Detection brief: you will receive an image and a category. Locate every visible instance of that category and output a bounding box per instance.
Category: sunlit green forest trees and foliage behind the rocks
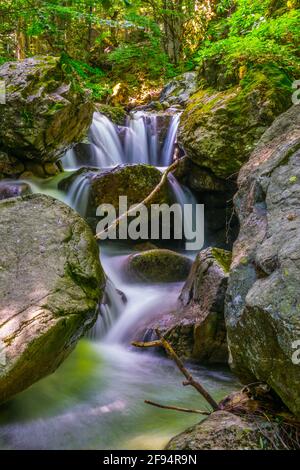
[0,0,300,100]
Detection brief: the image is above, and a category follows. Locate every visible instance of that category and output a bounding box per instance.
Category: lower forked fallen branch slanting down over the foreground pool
[131,329,220,411]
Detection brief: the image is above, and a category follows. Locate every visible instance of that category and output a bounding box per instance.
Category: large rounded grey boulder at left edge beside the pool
[0,195,104,402]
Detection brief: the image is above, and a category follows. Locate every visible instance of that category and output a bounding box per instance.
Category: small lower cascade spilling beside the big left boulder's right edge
[87,278,126,340]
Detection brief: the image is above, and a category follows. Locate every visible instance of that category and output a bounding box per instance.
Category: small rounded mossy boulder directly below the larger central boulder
[127,249,192,283]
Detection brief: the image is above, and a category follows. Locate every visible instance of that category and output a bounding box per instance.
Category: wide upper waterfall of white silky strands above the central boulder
[62,111,180,170]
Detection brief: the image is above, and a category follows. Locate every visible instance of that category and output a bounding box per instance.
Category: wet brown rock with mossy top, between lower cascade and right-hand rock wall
[139,248,231,363]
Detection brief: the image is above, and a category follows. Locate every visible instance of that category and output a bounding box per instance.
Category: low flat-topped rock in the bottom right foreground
[166,411,277,450]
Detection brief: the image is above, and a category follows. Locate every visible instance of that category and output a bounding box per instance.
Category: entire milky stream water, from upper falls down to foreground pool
[0,112,238,450]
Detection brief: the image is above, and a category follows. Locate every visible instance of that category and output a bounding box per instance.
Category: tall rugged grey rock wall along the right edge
[226,105,300,417]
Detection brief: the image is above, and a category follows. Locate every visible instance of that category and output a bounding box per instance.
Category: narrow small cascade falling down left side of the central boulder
[66,174,90,217]
